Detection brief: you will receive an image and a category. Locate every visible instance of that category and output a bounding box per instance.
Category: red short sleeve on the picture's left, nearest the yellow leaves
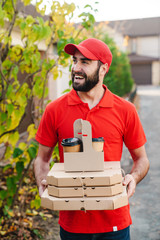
[36,107,58,147]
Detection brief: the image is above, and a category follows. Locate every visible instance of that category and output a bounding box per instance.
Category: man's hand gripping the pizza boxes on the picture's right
[122,174,136,198]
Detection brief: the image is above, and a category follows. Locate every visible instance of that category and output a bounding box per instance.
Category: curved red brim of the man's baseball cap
[64,43,98,60]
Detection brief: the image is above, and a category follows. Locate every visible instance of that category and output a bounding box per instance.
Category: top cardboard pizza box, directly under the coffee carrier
[47,168,122,187]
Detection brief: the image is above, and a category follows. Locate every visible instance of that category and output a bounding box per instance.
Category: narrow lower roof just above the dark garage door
[128,54,158,64]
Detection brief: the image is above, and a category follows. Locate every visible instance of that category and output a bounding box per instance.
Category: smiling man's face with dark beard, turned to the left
[71,51,100,92]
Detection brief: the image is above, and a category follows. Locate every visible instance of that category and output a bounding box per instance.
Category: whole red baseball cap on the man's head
[64,38,112,67]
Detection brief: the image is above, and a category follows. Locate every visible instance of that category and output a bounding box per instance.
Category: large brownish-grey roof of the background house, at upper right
[108,17,160,37]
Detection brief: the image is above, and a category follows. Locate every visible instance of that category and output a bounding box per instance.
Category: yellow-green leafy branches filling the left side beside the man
[0,0,94,233]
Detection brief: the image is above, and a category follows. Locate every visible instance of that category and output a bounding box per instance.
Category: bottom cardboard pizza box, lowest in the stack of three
[41,187,128,211]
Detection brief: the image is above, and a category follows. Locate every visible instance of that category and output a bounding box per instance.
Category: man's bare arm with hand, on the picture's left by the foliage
[34,144,53,196]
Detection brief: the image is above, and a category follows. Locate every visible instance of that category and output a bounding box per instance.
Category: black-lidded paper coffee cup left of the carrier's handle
[61,138,82,152]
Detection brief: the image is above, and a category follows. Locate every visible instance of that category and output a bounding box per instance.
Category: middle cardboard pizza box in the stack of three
[48,183,123,198]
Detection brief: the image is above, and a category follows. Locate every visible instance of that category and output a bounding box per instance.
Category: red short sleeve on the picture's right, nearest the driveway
[124,107,147,149]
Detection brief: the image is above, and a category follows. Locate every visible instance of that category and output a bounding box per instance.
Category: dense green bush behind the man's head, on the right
[103,35,133,96]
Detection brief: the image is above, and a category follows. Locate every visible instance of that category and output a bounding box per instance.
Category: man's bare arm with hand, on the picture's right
[123,146,149,197]
